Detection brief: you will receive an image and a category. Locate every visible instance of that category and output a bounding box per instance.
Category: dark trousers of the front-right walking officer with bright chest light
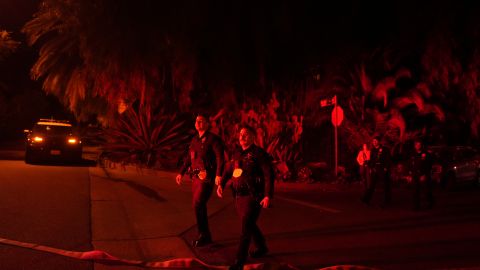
[235,195,266,264]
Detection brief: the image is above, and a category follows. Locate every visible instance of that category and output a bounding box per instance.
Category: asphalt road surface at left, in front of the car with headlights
[0,160,93,270]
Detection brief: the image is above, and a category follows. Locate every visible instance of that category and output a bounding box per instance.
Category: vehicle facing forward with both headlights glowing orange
[24,119,82,163]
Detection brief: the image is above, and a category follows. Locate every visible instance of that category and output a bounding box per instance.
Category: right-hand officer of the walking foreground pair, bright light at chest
[217,126,274,269]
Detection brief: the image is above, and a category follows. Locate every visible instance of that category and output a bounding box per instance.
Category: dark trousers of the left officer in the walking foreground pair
[192,177,213,237]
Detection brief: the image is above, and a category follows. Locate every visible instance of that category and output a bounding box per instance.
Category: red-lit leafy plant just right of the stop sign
[338,44,445,155]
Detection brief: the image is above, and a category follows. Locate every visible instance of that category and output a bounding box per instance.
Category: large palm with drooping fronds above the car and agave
[23,0,199,122]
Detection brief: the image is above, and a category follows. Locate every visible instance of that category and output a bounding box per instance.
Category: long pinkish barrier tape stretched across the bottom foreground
[0,238,300,270]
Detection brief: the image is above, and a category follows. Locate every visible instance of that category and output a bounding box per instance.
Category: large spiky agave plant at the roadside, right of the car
[103,107,190,167]
